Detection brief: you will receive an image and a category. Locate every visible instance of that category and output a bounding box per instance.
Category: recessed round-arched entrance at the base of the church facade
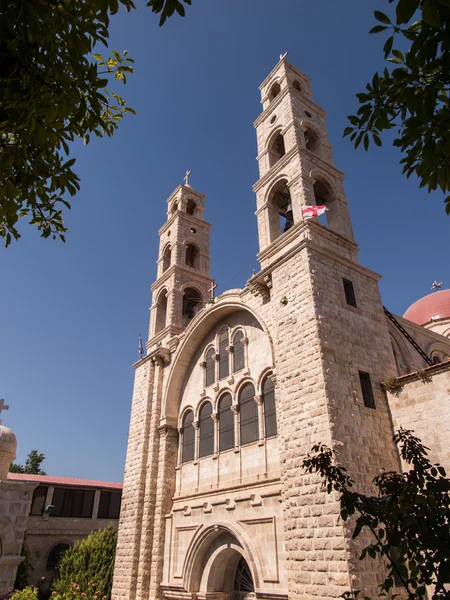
[188,526,258,600]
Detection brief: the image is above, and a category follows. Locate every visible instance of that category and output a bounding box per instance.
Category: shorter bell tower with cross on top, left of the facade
[147,175,214,349]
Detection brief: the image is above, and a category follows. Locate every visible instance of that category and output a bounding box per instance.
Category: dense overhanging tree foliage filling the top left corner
[0,0,191,246]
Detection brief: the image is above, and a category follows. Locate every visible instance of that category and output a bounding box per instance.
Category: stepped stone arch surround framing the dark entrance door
[183,523,262,598]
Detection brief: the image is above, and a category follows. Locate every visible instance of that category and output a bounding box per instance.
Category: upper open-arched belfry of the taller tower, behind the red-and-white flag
[253,56,353,267]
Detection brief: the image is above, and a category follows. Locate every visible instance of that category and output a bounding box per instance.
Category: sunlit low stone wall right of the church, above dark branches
[387,361,450,476]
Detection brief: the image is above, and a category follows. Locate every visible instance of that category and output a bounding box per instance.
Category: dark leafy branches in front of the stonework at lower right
[303,429,450,600]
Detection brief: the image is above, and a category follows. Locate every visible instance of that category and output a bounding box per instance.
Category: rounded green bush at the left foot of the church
[53,525,117,600]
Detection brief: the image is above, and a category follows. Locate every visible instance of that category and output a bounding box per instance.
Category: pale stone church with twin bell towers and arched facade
[113,57,450,600]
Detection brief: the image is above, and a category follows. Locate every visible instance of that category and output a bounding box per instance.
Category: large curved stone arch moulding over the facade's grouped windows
[161,296,275,427]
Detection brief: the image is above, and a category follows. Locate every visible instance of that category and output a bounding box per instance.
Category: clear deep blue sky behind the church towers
[0,0,450,481]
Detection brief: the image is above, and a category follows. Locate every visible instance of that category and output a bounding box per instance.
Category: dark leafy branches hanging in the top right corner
[344,0,450,214]
